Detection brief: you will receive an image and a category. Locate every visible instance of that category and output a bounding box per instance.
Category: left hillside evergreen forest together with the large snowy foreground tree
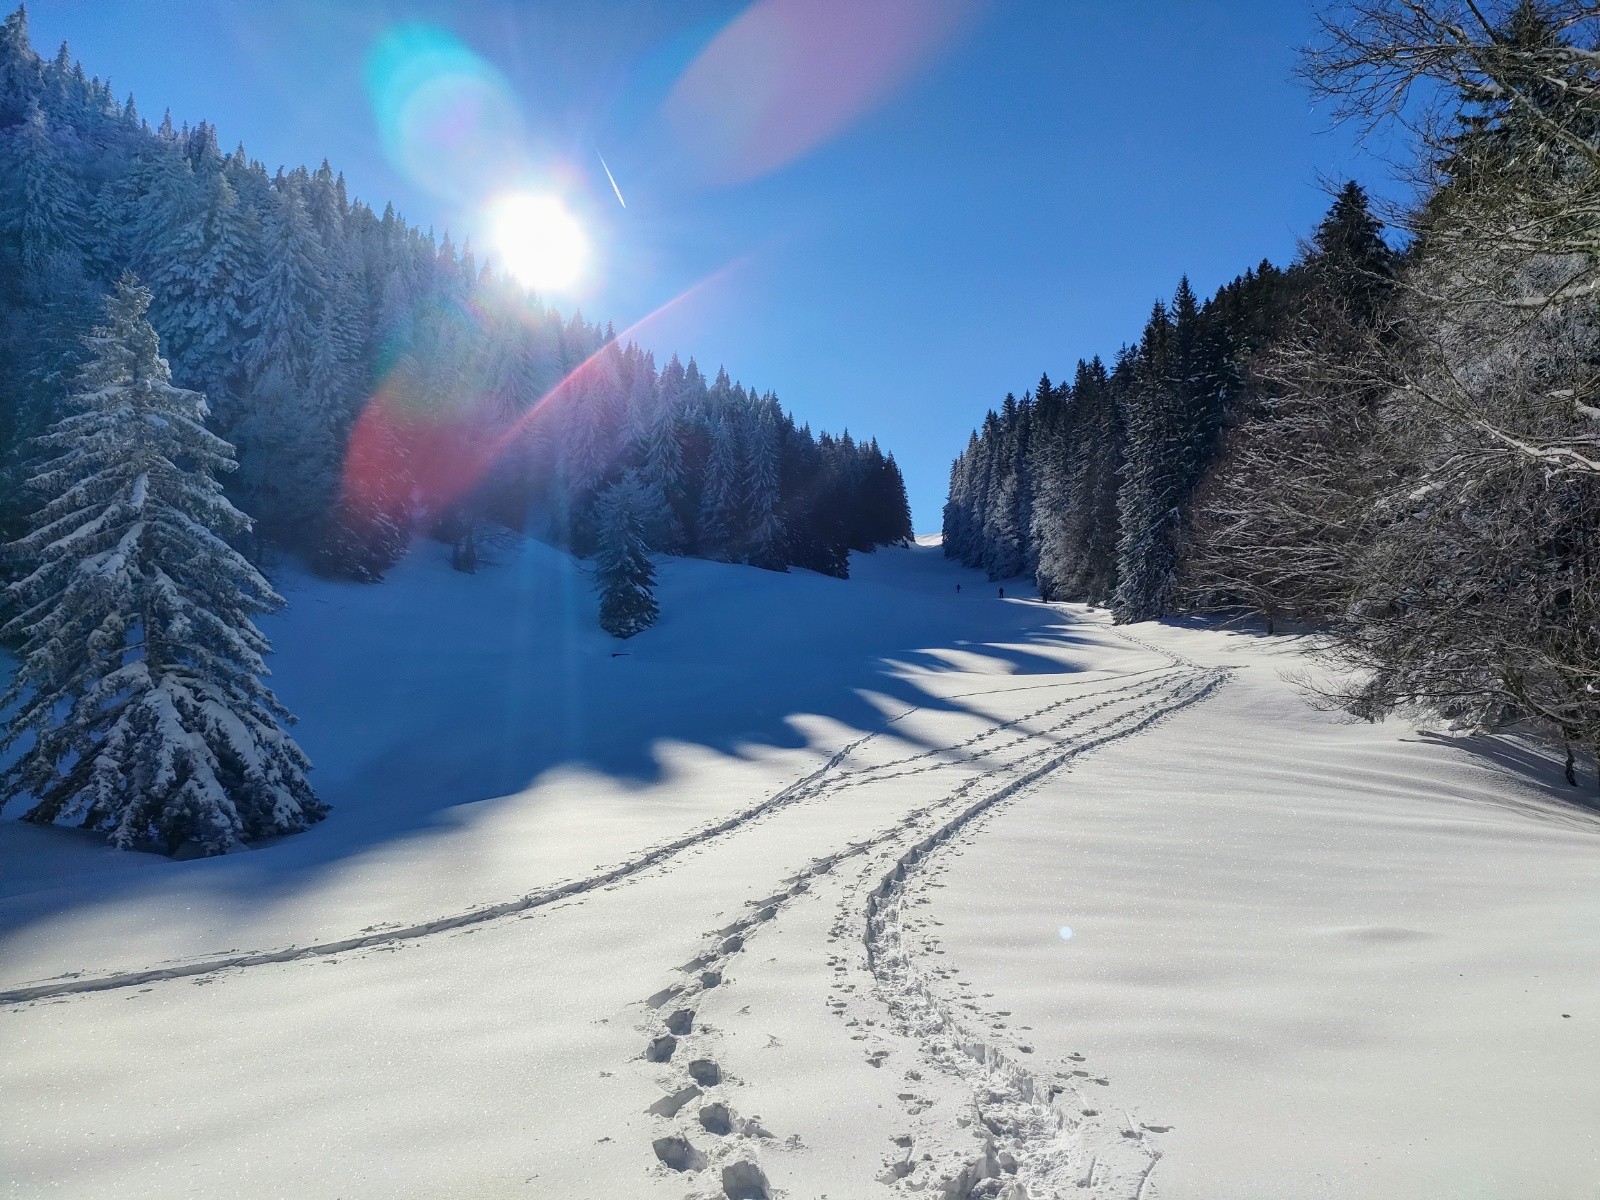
[0,10,910,854]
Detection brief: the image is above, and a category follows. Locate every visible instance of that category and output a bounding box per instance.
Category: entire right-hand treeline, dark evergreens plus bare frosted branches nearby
[946,0,1600,776]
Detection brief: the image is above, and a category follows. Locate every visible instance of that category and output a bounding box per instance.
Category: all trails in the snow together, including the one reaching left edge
[0,630,1230,1200]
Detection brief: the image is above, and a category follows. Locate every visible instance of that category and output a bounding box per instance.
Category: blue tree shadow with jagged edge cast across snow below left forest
[0,542,1126,966]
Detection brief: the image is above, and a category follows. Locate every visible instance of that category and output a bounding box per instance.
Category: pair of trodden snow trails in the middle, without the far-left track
[640,624,1230,1200]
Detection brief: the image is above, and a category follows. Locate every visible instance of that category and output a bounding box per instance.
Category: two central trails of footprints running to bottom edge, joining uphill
[640,630,1232,1200]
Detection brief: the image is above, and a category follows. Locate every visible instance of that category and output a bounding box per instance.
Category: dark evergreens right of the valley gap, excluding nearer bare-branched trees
[944,241,1324,621]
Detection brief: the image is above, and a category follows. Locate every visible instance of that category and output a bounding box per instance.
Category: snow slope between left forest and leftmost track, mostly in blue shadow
[0,542,1082,989]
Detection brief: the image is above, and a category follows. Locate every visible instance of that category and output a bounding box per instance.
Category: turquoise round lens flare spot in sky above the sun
[366,24,528,200]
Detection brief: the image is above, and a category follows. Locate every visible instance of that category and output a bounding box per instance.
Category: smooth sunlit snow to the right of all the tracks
[914,626,1600,1200]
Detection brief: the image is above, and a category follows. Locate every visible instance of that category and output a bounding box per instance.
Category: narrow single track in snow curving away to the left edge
[0,669,1177,1008]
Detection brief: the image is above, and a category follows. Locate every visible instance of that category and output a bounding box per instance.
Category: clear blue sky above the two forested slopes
[29,0,1394,531]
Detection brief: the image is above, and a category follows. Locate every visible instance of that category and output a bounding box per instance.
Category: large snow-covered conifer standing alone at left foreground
[0,275,326,854]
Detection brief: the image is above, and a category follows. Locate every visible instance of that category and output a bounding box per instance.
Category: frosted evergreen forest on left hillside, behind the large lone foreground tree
[0,10,910,595]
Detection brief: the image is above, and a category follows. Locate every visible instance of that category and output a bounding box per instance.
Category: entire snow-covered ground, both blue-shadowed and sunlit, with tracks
[0,547,1600,1200]
